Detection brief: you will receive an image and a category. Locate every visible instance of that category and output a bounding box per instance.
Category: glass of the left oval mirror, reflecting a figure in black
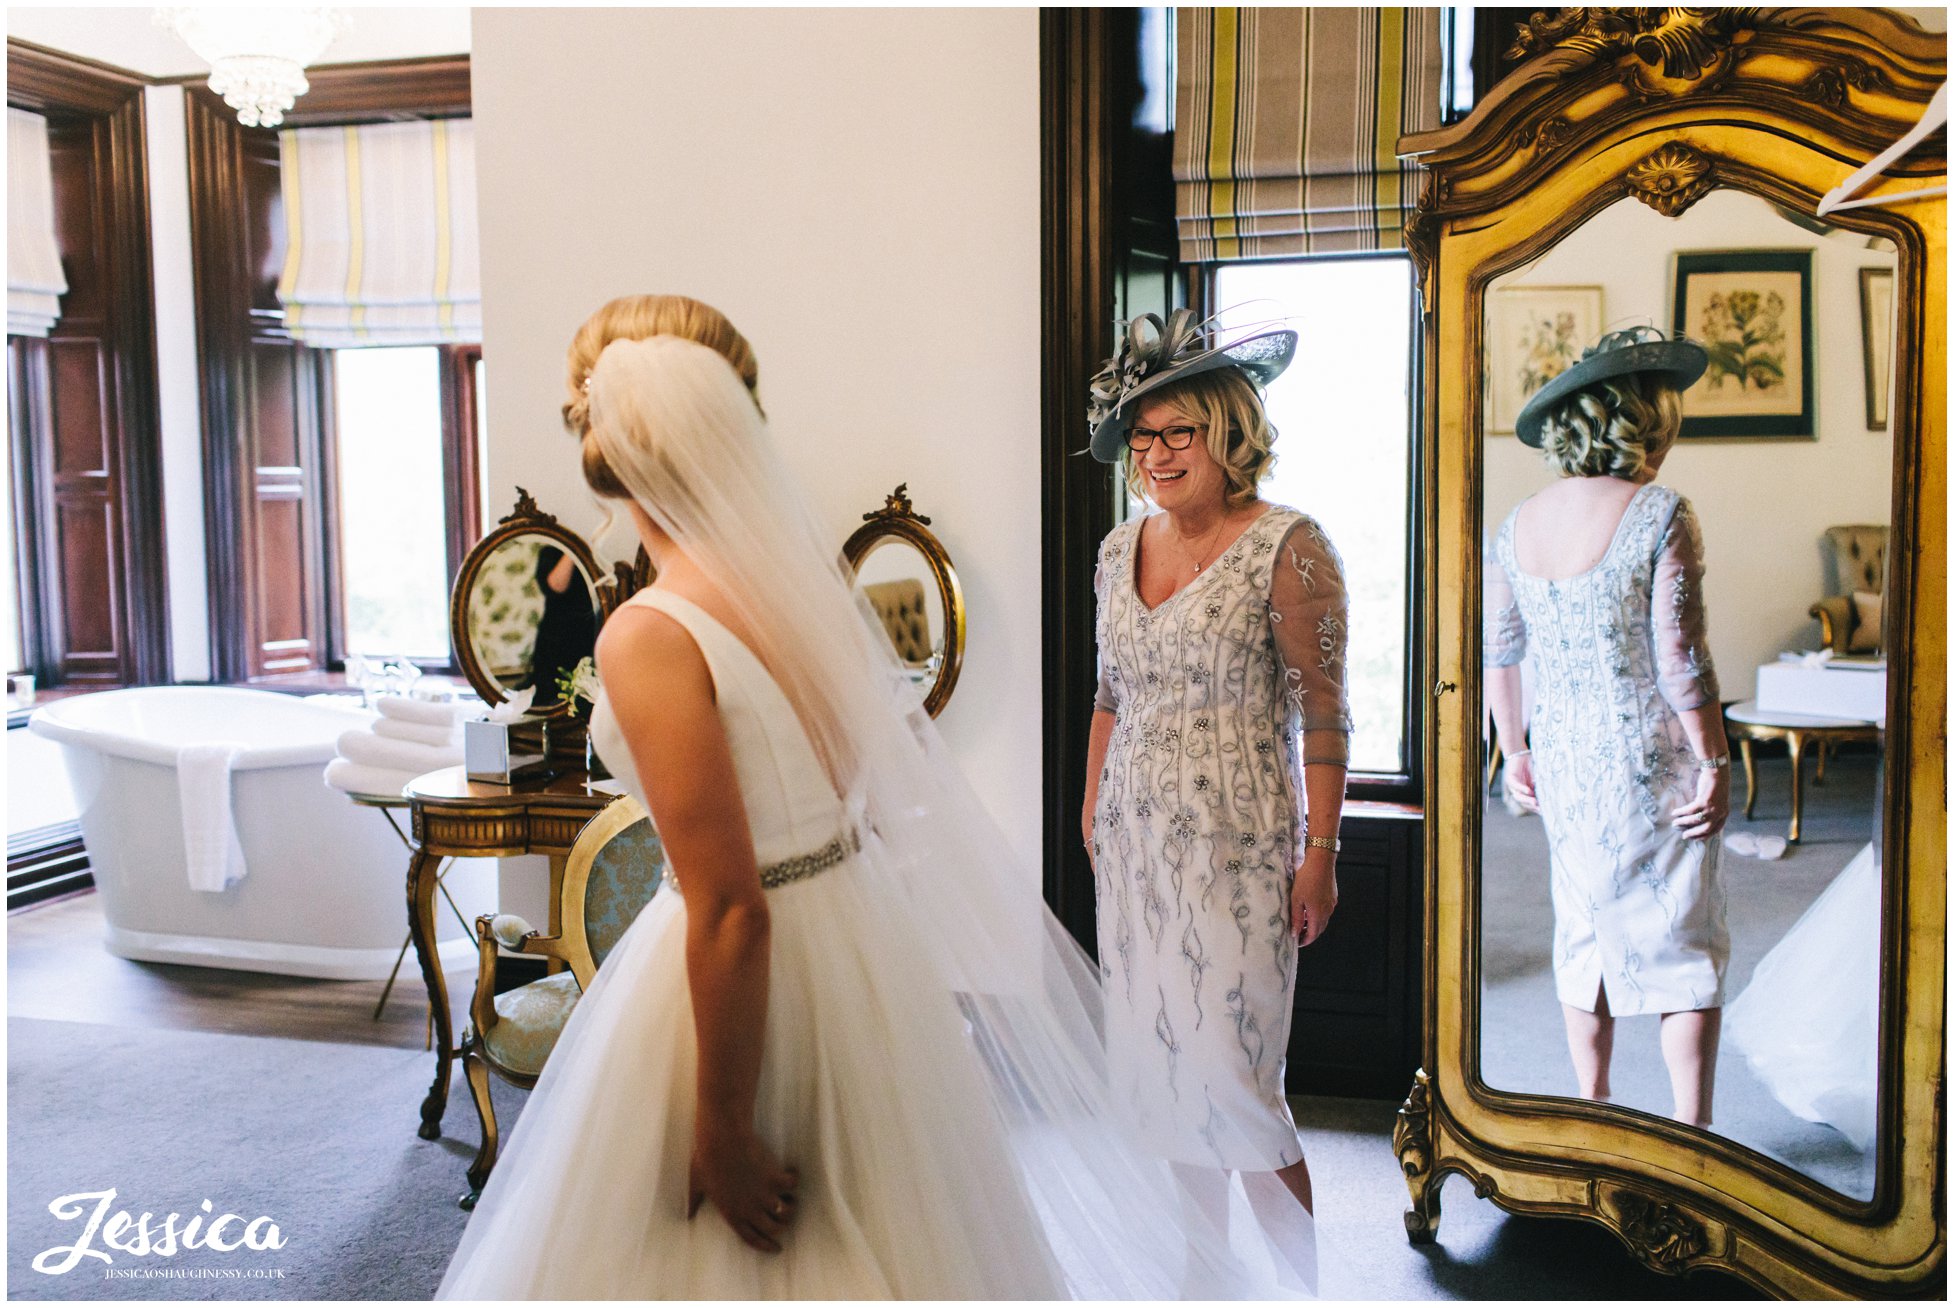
[467,532,598,708]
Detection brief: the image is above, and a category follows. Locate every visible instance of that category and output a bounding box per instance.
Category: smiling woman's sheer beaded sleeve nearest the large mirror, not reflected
[1268,518,1350,764]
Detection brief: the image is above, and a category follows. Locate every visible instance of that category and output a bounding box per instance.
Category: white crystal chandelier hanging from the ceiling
[156,4,346,127]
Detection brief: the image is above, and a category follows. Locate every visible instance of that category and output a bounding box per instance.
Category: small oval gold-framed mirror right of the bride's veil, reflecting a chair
[842,481,965,718]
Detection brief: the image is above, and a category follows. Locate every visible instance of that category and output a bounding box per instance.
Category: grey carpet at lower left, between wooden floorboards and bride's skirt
[8,1019,522,1300]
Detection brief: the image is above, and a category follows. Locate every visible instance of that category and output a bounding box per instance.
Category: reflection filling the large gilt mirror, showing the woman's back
[1479,192,1895,1199]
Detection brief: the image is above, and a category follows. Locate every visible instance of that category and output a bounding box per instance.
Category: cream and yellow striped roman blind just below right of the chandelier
[277,117,483,348]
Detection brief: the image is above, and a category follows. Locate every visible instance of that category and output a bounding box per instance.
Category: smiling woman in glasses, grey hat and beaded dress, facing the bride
[1083,313,1350,1222]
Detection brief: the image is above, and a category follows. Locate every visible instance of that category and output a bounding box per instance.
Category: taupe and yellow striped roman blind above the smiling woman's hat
[1174,6,1442,262]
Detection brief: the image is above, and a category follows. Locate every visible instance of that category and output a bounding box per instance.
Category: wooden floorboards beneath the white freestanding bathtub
[6,892,457,1050]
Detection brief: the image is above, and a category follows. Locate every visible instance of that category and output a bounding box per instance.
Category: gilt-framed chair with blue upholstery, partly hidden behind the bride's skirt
[461,796,664,1208]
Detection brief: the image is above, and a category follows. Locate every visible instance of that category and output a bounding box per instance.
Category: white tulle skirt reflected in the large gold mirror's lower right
[1723,845,1880,1150]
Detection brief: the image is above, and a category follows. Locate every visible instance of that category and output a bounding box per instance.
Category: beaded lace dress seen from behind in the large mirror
[1485,483,1729,1017]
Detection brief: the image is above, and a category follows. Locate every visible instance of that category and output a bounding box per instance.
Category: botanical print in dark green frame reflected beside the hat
[1675,250,1817,438]
